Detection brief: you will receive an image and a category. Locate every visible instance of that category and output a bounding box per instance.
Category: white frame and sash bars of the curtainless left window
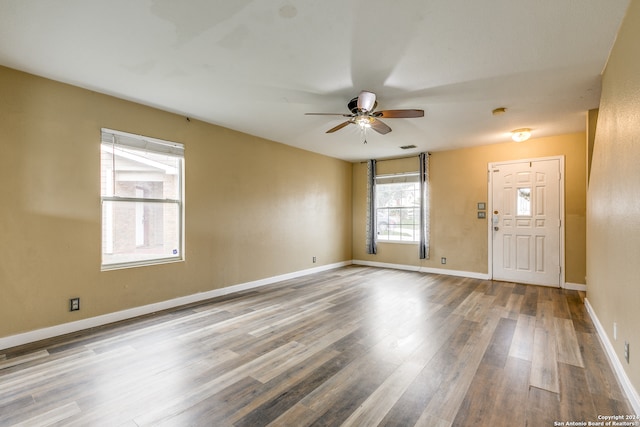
[100,128,185,271]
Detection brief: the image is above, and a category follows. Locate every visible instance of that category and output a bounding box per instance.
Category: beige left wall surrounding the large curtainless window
[0,68,352,337]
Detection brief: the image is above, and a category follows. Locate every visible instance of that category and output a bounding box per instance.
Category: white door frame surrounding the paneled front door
[487,155,566,288]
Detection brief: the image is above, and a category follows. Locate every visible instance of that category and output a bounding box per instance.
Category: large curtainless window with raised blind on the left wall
[100,129,184,270]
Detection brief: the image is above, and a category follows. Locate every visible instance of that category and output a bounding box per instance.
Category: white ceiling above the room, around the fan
[0,0,629,161]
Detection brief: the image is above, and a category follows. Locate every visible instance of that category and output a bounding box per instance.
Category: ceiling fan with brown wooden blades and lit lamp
[305,91,424,136]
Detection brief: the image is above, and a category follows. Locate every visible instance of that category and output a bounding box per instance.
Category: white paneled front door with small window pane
[488,158,562,287]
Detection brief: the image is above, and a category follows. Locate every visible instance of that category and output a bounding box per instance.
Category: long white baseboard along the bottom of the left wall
[0,261,351,350]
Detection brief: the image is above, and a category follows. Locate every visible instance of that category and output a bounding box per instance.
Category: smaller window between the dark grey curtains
[376,173,420,242]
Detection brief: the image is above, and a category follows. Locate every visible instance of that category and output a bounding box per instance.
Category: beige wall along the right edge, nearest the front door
[587,0,640,390]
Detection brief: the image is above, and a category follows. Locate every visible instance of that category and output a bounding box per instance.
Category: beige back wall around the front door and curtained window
[353,133,586,284]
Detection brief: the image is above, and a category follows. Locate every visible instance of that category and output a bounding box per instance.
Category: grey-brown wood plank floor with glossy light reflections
[0,266,632,427]
